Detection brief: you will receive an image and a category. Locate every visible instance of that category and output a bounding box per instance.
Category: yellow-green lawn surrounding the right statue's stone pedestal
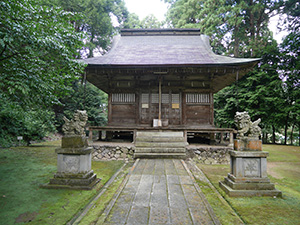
[197,145,300,225]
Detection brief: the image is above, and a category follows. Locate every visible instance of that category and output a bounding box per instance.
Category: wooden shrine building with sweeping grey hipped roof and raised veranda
[84,29,259,154]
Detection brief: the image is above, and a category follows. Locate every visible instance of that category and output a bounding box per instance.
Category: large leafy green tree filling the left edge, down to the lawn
[0,0,84,146]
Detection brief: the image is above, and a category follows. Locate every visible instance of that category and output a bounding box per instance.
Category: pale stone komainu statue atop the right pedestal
[234,112,261,139]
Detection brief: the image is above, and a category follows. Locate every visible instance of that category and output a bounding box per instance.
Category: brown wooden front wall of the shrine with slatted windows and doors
[108,90,213,127]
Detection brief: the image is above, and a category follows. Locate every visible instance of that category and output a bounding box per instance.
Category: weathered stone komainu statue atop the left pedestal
[62,110,88,136]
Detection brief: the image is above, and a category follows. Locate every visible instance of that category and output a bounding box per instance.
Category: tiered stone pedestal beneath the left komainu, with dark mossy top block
[44,135,100,190]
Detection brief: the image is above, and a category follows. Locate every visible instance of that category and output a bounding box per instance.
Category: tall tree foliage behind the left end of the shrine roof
[42,0,128,58]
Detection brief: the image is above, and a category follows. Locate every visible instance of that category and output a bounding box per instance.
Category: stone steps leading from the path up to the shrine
[134,131,186,158]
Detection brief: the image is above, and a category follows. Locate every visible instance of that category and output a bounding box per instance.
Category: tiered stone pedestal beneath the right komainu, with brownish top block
[219,138,282,197]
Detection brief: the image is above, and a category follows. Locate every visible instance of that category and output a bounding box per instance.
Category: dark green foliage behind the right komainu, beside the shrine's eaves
[214,41,284,132]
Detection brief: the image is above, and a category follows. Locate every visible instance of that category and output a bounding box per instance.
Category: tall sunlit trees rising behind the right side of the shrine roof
[167,0,280,57]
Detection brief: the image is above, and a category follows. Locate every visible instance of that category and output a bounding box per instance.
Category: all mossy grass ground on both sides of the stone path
[0,141,300,225]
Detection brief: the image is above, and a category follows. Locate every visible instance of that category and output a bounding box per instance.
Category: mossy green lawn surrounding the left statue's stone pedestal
[0,141,124,224]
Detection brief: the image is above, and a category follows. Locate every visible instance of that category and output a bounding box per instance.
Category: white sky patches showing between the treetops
[124,0,287,43]
